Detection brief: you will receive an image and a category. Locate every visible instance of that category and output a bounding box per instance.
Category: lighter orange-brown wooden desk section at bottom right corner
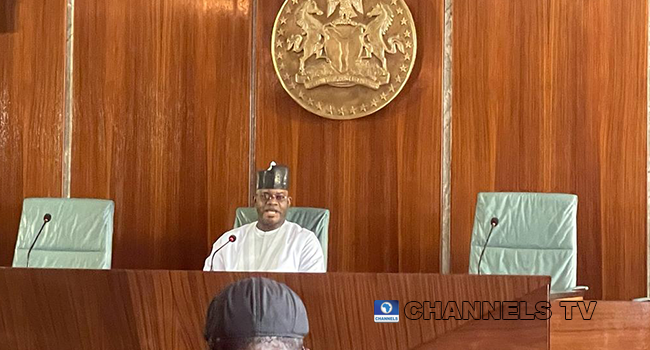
[551,301,650,350]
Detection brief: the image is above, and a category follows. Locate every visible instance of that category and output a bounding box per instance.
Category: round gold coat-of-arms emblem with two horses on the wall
[271,0,417,119]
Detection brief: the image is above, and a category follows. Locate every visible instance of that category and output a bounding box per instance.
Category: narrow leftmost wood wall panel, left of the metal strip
[0,0,65,266]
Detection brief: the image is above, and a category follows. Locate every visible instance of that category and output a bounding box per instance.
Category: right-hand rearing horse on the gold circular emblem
[365,2,404,70]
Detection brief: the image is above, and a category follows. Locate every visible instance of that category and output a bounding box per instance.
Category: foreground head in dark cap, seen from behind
[204,277,309,350]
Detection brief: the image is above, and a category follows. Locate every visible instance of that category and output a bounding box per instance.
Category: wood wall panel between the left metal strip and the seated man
[71,0,251,269]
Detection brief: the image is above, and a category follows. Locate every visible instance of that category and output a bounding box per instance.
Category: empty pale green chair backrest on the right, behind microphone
[469,192,578,293]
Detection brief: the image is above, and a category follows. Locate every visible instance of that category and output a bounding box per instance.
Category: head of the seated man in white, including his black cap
[255,162,291,231]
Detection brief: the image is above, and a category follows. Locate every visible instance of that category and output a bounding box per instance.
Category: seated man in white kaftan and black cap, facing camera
[203,163,325,272]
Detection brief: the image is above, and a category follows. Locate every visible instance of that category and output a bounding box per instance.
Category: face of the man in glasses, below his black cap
[255,190,291,231]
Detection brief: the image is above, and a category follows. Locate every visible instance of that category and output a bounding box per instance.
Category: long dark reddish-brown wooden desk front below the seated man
[0,268,550,350]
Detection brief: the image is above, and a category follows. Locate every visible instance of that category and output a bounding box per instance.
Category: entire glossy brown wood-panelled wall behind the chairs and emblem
[0,0,647,299]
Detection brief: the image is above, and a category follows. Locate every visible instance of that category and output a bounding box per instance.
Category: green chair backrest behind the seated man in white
[234,207,330,270]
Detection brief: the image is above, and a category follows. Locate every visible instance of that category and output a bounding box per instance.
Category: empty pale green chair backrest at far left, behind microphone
[12,198,115,269]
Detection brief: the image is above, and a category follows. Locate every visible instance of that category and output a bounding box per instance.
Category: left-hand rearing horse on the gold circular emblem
[287,0,323,73]
